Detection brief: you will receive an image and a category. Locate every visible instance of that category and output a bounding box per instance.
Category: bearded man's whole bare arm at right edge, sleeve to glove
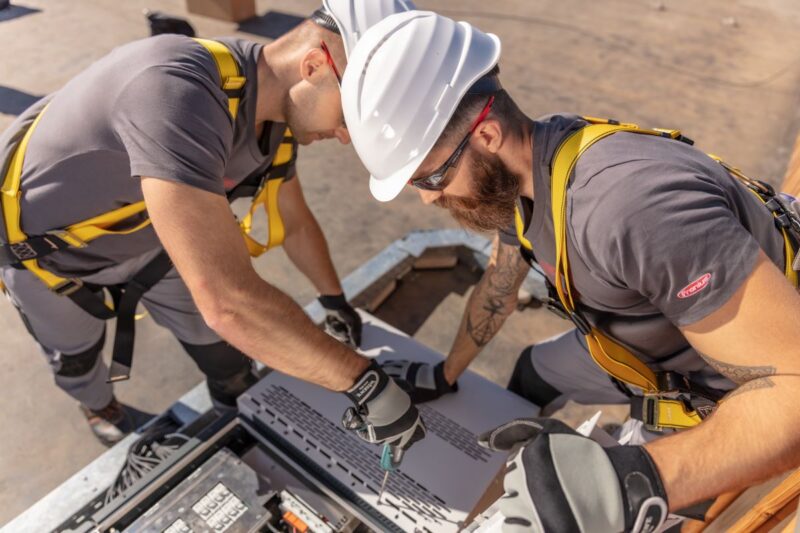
[645,253,800,510]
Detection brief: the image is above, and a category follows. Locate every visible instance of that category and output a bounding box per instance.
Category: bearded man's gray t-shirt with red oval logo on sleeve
[500,115,784,388]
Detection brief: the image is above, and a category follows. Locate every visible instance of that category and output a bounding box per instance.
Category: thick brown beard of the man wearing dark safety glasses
[435,151,519,233]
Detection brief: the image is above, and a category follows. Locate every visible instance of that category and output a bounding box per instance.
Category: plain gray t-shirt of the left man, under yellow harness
[0,35,294,276]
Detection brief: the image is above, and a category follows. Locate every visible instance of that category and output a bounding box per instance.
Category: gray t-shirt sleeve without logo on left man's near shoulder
[114,66,233,195]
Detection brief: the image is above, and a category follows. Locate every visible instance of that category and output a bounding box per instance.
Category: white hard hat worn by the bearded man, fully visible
[342,11,500,202]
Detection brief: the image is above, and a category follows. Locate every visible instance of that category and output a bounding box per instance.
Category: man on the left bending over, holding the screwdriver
[0,0,424,458]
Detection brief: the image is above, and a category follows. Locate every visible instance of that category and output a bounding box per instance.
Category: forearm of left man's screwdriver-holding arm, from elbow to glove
[198,276,368,391]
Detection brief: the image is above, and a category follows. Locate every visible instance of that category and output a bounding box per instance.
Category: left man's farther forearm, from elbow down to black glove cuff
[283,216,342,294]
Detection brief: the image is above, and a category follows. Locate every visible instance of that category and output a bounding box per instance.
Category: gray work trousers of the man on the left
[0,250,238,409]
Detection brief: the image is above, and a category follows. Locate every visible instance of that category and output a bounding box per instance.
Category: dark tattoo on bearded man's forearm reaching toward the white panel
[466,245,528,348]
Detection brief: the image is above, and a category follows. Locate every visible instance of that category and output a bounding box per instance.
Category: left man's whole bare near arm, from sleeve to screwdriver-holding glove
[142,177,368,390]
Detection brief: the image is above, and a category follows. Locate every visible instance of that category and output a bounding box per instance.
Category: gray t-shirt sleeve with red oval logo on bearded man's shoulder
[570,161,760,326]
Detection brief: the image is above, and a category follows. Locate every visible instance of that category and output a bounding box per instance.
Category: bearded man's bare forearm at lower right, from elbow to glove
[646,367,800,510]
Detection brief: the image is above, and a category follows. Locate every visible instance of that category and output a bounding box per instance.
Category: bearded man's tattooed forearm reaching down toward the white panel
[444,236,530,384]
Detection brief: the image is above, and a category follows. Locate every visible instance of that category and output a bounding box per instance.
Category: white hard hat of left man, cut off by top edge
[312,0,416,56]
